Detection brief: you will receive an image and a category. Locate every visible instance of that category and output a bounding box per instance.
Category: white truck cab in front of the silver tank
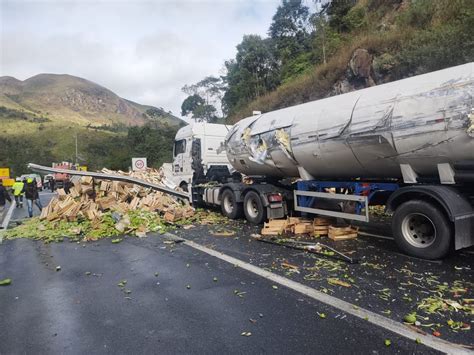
[167,123,234,190]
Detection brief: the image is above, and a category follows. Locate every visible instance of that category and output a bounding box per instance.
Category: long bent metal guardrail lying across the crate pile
[28,163,189,201]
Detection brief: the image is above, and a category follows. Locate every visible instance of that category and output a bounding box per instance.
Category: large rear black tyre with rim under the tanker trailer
[392,200,452,260]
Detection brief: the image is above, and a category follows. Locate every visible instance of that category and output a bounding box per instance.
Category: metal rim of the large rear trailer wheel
[402,213,436,248]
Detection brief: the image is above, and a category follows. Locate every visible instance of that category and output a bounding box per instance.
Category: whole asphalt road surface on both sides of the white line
[0,194,474,354]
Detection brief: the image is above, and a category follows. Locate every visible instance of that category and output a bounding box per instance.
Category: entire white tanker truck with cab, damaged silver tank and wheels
[173,63,474,259]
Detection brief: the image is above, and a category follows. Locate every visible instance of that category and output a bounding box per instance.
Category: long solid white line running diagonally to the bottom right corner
[165,233,474,355]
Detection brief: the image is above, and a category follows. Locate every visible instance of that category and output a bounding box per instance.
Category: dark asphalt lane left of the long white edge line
[0,237,438,354]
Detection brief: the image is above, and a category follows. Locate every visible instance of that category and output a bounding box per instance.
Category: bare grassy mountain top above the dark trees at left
[0,74,182,127]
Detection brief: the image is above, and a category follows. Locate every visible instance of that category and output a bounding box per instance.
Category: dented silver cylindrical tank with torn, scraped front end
[226,63,474,180]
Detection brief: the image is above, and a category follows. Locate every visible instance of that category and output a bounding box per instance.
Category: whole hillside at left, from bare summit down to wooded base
[0,74,183,175]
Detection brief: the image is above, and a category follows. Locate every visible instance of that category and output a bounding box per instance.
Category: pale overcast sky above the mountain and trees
[0,0,280,115]
